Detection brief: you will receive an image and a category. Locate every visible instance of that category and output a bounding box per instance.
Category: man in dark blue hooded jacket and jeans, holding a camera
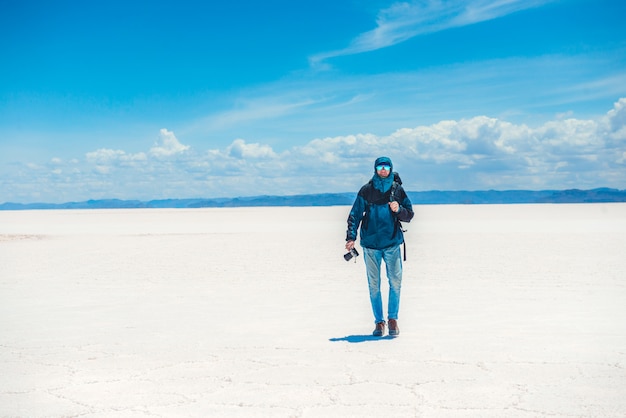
[346,157,414,337]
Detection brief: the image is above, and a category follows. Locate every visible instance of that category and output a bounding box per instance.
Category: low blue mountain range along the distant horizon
[0,188,626,210]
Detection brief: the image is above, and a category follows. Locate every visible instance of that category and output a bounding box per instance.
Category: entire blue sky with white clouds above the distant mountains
[0,0,626,203]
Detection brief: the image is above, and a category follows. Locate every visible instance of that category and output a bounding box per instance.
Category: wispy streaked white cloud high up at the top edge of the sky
[309,0,554,67]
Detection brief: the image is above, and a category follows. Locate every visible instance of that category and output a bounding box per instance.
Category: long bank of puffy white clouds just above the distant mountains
[0,98,626,203]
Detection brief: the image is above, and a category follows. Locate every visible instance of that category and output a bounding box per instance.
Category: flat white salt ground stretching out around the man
[0,204,626,418]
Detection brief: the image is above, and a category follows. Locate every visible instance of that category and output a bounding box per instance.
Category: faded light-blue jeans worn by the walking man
[363,246,402,322]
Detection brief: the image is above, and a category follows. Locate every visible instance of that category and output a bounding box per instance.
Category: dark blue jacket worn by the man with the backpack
[346,173,414,250]
